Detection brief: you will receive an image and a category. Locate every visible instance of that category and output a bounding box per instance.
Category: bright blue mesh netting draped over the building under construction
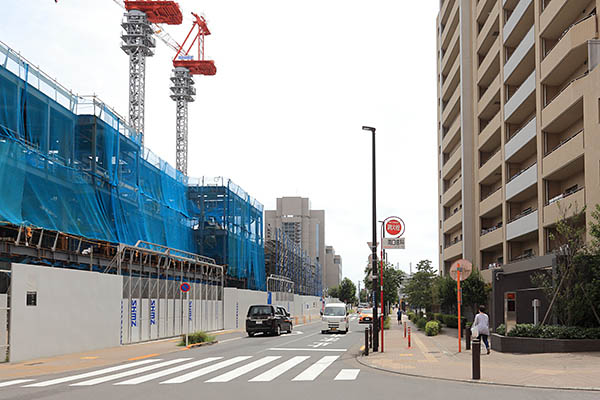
[0,42,266,289]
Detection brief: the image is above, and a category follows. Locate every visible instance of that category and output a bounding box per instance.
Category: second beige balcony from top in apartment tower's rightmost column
[540,15,597,86]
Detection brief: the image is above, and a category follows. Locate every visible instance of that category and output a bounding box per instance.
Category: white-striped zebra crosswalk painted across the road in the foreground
[0,355,360,388]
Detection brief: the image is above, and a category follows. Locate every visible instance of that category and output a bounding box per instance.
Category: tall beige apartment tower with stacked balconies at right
[437,0,600,273]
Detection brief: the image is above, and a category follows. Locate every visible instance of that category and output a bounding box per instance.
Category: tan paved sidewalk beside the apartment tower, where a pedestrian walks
[358,317,600,391]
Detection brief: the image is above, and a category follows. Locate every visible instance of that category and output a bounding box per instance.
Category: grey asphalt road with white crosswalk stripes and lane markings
[0,321,600,400]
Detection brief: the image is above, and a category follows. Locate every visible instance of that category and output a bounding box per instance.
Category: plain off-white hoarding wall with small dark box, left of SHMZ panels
[10,264,123,362]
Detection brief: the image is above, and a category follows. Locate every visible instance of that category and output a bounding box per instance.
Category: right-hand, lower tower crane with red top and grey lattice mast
[171,13,217,175]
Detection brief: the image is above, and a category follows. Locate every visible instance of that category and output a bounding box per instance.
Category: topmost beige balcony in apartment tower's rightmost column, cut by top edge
[540,0,590,38]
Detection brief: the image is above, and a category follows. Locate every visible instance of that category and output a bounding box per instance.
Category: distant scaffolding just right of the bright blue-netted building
[265,227,323,296]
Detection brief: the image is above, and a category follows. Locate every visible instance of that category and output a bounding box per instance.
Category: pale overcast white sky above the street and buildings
[0,0,439,285]
